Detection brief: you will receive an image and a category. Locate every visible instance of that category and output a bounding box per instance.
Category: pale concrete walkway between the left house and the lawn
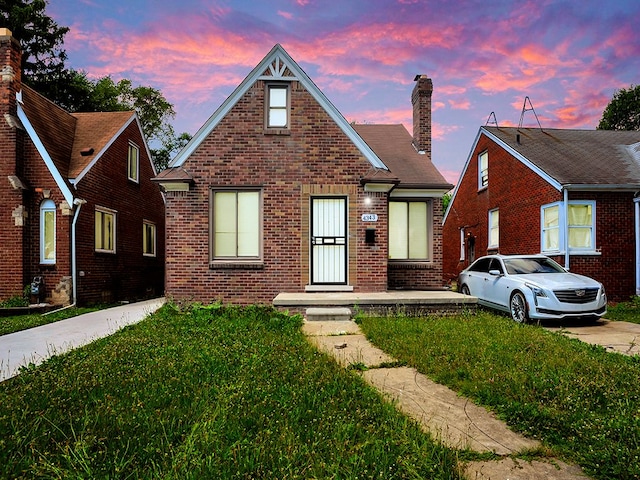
[0,298,165,382]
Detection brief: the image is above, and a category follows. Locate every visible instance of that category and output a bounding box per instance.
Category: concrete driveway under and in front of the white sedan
[542,318,640,355]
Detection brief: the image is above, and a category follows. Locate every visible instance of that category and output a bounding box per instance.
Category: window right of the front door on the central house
[389,200,431,261]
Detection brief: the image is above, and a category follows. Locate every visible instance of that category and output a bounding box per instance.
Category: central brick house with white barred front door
[155,45,452,304]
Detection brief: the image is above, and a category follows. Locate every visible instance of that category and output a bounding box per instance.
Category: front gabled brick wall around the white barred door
[166,81,387,303]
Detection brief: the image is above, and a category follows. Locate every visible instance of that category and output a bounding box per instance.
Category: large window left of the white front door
[210,189,262,262]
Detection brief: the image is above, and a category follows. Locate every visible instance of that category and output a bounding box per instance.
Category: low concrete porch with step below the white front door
[273,290,477,320]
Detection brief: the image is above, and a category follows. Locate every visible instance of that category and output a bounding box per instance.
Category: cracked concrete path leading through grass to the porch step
[303,321,588,480]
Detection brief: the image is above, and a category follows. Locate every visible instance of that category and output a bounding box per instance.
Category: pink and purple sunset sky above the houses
[46,0,640,183]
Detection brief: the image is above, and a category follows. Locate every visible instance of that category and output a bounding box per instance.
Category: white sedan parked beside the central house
[458,255,607,323]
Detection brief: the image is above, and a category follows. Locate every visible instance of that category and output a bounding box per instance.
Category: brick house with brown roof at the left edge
[0,29,164,305]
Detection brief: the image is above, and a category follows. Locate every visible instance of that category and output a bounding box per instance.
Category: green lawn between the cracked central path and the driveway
[360,312,640,479]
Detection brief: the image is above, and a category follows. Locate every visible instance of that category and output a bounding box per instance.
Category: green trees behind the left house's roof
[0,0,191,170]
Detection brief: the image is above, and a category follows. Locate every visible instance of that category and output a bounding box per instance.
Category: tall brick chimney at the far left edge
[0,28,27,299]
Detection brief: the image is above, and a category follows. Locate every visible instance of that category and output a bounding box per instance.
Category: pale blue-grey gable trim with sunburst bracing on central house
[169,44,388,170]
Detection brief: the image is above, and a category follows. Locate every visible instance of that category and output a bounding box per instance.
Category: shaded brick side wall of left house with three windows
[76,122,165,303]
